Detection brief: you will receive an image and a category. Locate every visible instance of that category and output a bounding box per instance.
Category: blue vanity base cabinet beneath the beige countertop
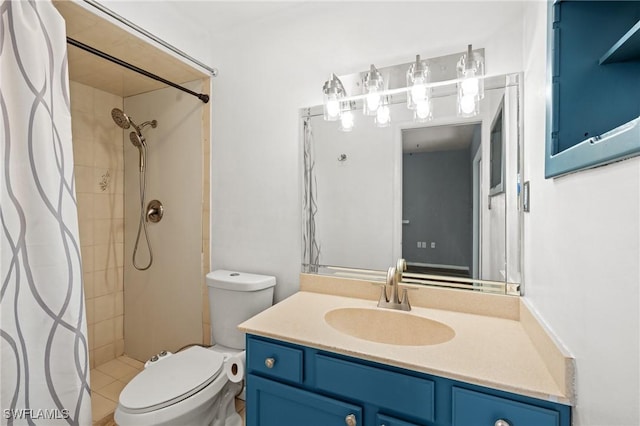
[247,335,571,426]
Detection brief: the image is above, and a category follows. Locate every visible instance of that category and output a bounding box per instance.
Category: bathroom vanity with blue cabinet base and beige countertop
[240,278,573,426]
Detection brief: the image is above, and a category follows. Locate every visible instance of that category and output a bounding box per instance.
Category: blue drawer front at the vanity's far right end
[453,387,560,426]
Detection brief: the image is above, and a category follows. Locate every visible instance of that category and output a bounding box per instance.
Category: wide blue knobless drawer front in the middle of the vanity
[315,355,435,422]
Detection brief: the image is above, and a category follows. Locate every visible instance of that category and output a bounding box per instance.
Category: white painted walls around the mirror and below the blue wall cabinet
[87,2,640,426]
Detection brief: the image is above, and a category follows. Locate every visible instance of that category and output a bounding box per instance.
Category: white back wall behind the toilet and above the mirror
[204,2,522,299]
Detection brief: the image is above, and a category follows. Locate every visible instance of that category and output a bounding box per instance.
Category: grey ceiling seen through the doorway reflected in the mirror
[402,123,480,154]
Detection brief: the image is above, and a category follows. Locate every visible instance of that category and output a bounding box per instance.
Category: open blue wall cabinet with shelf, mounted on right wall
[545,0,640,177]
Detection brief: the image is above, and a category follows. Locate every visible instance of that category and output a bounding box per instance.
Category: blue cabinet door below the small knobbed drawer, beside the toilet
[247,374,363,426]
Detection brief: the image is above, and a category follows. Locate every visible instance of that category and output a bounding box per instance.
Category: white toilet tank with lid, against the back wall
[207,269,276,350]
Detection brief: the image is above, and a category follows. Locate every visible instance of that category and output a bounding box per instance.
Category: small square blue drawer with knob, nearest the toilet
[247,338,303,383]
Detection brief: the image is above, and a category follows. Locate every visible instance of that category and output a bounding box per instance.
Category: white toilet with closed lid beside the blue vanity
[114,270,276,426]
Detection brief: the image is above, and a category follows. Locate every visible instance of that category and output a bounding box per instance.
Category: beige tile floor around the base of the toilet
[91,356,245,426]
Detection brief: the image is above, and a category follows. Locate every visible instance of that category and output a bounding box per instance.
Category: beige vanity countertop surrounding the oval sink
[239,291,573,404]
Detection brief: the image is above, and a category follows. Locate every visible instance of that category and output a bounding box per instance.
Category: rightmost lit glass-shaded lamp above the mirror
[456,45,484,117]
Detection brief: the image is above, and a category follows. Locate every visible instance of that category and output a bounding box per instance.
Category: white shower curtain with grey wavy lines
[0,0,91,425]
